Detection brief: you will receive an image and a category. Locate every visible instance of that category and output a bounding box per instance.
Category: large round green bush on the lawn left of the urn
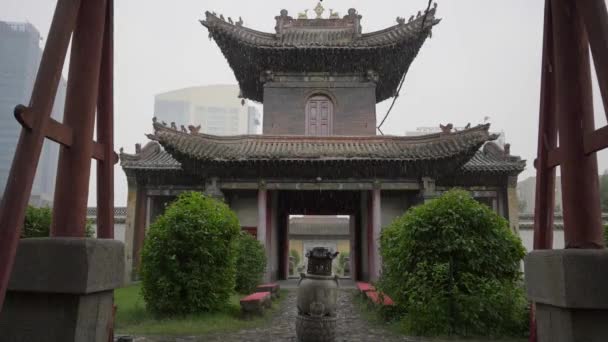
[140,192,240,316]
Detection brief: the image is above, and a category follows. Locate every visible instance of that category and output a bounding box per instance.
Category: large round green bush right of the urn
[378,190,527,336]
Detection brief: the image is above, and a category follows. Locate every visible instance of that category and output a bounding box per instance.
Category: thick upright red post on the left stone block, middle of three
[51,0,106,237]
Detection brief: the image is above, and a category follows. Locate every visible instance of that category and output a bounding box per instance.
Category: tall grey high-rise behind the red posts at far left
[0,21,66,206]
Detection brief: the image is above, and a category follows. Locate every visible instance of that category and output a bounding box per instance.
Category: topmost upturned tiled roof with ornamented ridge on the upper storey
[201,5,440,102]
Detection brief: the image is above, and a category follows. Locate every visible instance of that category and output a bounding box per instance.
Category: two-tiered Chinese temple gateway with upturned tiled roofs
[121,5,525,280]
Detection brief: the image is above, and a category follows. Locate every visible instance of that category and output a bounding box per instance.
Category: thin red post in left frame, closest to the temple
[97,0,115,239]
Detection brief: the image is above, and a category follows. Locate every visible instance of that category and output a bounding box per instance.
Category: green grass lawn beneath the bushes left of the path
[114,285,286,336]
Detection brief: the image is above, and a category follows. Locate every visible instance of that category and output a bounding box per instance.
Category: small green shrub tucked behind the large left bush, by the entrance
[235,231,266,293]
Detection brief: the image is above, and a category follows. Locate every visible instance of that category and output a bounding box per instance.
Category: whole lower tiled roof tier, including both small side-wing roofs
[120,122,525,179]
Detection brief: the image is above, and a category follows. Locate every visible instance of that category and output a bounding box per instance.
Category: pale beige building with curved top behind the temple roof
[154,84,262,135]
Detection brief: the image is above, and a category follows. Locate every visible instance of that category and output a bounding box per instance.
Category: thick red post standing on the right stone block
[552,0,604,248]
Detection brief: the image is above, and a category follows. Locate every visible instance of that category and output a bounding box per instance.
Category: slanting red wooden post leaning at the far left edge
[0,0,80,308]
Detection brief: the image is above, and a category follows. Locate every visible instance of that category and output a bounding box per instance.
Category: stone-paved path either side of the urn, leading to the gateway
[123,290,419,342]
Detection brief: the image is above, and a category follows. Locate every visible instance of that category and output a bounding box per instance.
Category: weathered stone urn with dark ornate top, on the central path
[296,247,339,342]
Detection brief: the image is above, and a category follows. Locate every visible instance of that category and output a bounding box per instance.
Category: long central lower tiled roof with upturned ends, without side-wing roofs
[148,122,496,162]
